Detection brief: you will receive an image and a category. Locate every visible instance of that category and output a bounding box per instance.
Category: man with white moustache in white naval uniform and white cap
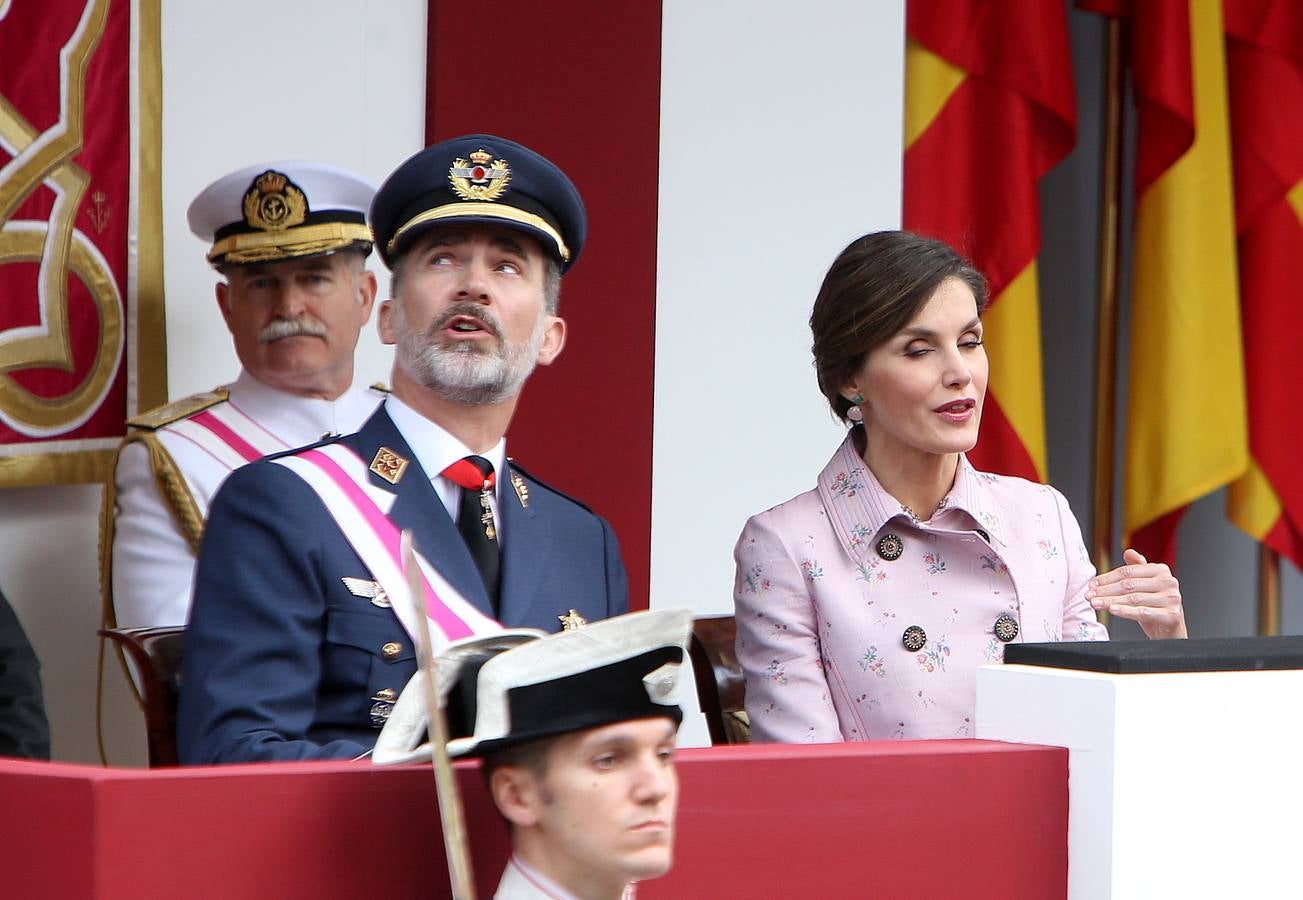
[102,162,383,626]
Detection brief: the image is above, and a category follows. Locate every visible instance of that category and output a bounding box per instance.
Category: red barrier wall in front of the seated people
[0,741,1067,900]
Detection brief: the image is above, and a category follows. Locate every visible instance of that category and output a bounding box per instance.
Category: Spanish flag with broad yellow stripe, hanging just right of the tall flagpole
[1083,0,1248,563]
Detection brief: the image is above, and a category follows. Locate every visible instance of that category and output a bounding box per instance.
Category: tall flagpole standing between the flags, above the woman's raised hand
[1091,17,1122,591]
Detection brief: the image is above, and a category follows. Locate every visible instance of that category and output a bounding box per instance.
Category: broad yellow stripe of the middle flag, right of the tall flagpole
[1123,0,1248,537]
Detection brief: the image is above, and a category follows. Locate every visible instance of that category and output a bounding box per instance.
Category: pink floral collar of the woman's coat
[817,430,1006,556]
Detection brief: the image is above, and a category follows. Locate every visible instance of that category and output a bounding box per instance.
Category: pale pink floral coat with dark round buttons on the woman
[734,436,1108,742]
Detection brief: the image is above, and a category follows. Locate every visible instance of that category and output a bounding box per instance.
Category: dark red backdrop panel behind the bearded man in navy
[426,0,656,610]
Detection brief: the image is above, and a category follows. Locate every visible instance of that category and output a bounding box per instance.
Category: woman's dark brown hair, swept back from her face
[810,232,986,422]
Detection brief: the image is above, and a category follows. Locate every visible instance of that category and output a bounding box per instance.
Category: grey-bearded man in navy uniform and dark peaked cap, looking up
[177,134,628,763]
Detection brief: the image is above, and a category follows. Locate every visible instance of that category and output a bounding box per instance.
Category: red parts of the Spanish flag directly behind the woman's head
[904,0,1076,481]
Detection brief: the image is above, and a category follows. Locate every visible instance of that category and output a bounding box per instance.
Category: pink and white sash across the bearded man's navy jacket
[274,444,502,653]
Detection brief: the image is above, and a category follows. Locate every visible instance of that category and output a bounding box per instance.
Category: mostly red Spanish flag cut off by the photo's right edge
[1225,0,1303,568]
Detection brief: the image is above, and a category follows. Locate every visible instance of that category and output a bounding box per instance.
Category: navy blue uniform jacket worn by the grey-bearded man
[177,406,628,763]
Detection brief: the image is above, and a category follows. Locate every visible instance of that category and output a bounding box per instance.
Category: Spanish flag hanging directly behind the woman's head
[904,0,1076,481]
